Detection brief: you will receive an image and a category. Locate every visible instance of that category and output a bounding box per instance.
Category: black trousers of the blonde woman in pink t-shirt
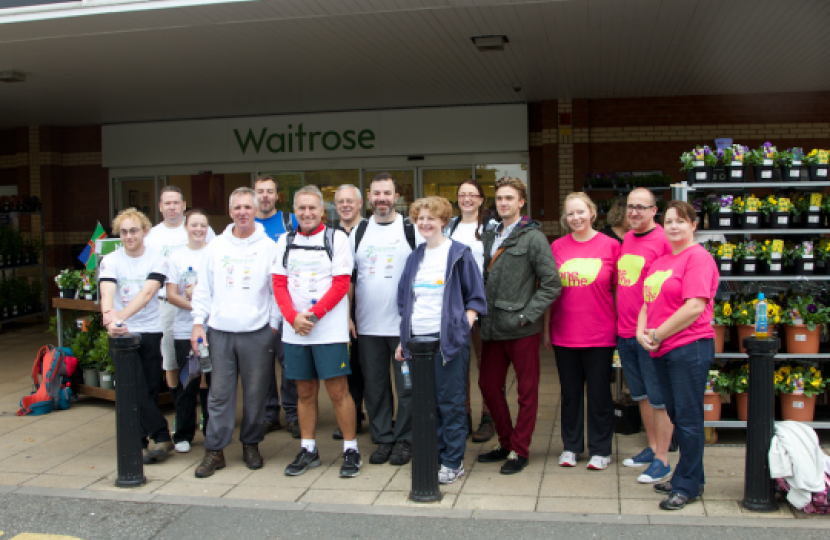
[553,346,614,456]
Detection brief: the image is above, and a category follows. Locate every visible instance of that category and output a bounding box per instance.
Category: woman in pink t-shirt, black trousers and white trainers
[542,193,620,470]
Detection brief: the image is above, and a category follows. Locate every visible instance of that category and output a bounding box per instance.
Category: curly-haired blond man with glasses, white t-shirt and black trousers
[103,208,173,463]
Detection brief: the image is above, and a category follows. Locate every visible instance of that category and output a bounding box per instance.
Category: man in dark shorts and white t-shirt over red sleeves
[271,185,363,478]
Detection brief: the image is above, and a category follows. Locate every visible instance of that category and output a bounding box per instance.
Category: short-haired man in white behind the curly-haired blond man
[144,186,216,380]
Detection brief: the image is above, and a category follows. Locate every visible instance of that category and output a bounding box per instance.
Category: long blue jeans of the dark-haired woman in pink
[654,339,715,498]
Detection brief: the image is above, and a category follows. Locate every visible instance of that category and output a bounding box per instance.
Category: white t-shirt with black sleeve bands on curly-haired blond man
[98,247,167,334]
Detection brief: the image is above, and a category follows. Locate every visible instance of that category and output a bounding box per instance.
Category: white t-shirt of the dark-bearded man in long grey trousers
[349,215,424,336]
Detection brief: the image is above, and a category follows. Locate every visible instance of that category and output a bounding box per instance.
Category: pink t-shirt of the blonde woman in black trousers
[550,233,620,347]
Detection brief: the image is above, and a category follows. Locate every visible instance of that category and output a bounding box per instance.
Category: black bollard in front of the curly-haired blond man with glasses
[109,334,147,487]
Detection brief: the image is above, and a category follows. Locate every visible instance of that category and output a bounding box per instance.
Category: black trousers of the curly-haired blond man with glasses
[137,332,170,448]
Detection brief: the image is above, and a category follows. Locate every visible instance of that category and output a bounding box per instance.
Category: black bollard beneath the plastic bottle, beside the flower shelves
[741,337,781,512]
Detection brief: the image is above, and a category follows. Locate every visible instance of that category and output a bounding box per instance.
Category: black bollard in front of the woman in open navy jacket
[406,337,443,502]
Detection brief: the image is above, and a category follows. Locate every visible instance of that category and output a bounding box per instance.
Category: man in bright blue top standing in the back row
[254,176,300,439]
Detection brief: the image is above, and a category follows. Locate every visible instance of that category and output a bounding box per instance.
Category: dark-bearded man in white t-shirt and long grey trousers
[349,173,424,465]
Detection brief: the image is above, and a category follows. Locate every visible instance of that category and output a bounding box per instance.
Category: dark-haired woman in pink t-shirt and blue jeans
[637,201,720,510]
